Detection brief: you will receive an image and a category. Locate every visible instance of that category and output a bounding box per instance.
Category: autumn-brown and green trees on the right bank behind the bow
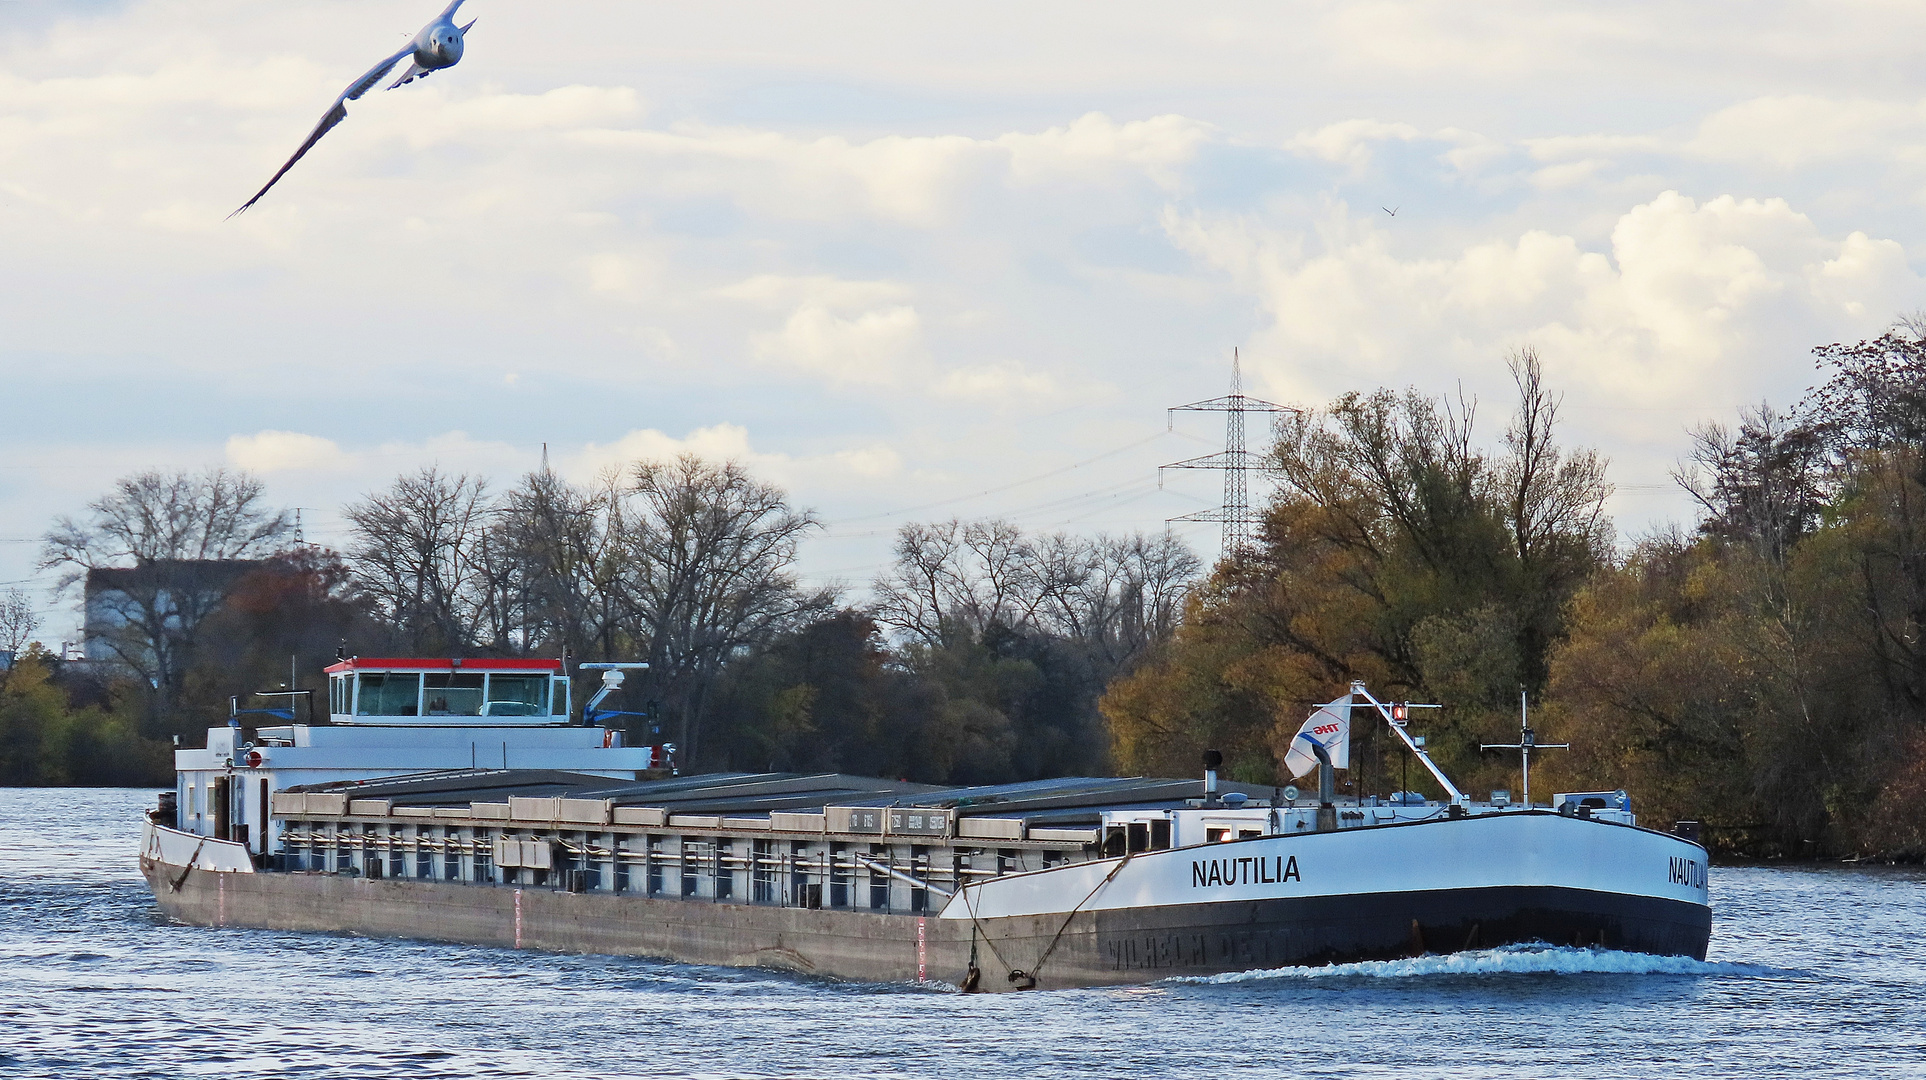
[1102,333,1926,857]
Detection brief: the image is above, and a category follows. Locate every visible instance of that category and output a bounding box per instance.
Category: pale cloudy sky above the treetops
[0,0,1926,641]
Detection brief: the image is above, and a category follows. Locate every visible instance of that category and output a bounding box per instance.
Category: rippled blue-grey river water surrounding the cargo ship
[0,789,1926,1080]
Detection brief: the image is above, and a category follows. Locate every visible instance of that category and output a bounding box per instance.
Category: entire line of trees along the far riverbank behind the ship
[18,325,1926,857]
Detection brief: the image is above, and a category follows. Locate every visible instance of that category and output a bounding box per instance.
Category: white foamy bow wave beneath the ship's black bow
[1171,945,1799,984]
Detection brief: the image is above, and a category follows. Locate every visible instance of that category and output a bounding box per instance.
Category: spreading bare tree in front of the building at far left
[40,468,291,708]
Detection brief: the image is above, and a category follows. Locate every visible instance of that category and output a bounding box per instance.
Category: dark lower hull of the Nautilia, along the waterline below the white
[143,839,1710,990]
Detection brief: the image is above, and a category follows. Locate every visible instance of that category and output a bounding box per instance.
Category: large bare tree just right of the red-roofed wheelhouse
[614,454,834,759]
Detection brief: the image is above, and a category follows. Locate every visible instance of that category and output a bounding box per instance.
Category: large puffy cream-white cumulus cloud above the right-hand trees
[1167,184,1920,406]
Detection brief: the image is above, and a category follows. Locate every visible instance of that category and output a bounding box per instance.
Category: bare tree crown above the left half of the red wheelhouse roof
[343,466,503,653]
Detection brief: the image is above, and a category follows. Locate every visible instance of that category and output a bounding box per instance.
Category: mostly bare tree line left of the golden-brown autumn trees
[0,456,1202,784]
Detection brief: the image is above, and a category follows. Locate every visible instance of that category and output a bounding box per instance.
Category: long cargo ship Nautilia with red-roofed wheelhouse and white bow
[141,658,1712,991]
